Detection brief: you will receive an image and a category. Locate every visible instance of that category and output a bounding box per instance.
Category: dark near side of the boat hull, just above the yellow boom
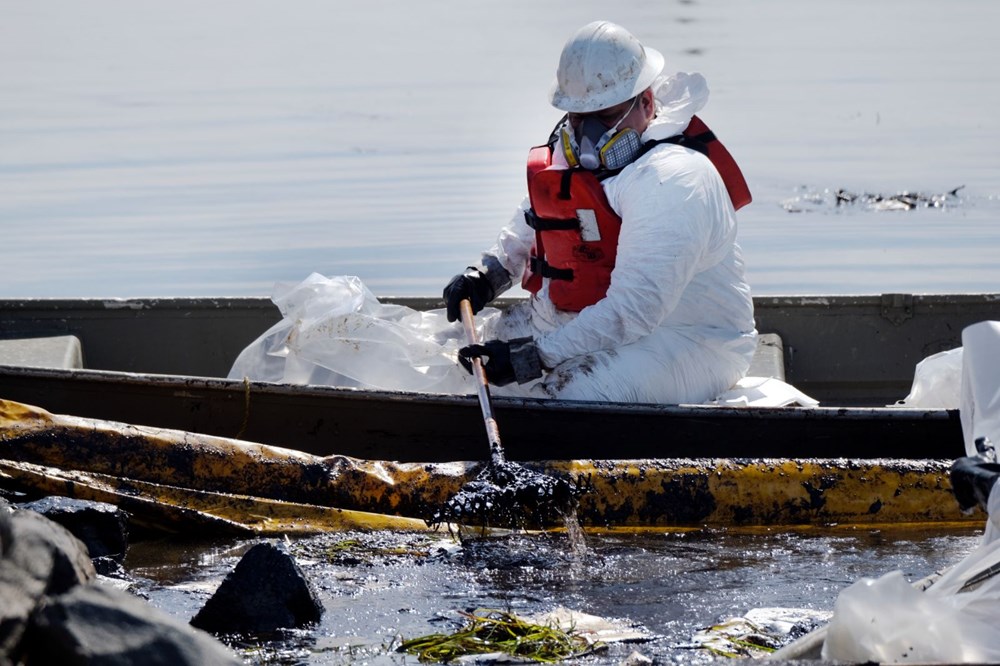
[0,368,964,462]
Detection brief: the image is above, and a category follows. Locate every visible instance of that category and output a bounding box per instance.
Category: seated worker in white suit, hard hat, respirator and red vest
[444,21,757,404]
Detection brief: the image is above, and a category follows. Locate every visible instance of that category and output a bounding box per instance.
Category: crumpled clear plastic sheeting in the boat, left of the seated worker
[229,273,480,394]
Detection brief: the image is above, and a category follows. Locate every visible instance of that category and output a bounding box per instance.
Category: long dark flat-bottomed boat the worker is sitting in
[0,294,988,462]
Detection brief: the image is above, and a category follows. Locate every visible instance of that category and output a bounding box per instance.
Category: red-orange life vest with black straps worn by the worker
[521,116,751,312]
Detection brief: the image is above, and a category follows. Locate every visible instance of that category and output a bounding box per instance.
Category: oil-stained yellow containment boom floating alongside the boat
[0,400,984,533]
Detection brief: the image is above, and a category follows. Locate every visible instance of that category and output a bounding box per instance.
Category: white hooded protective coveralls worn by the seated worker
[483,73,756,404]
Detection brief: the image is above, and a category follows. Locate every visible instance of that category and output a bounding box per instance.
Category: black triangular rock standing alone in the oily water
[191,542,323,634]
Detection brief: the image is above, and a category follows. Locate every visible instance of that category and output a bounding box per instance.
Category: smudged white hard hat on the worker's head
[550,21,663,113]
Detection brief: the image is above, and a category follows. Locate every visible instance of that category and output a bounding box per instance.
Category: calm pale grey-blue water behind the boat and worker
[0,0,1000,297]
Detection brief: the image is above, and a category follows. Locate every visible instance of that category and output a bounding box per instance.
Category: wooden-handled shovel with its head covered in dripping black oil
[428,299,576,527]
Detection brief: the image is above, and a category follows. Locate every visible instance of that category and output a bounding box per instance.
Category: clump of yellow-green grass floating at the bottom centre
[397,610,604,663]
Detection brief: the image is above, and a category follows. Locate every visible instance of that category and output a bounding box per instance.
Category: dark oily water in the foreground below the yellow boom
[126,528,979,665]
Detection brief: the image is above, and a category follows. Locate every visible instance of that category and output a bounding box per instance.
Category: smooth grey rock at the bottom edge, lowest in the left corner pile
[25,585,243,666]
